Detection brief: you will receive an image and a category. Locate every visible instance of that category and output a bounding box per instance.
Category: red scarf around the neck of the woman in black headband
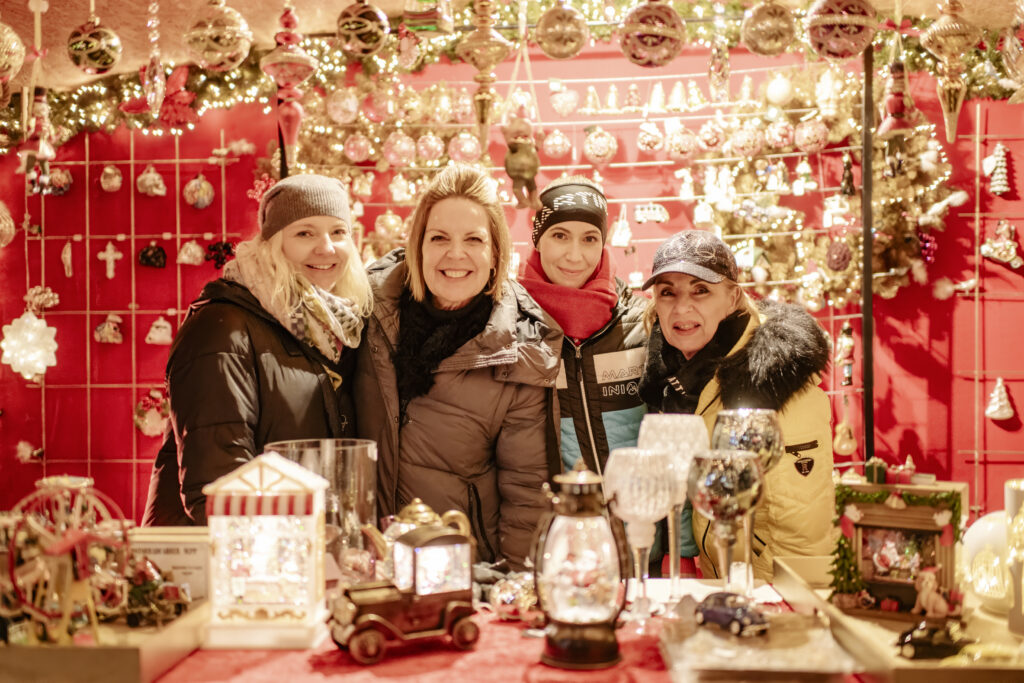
[519,247,618,341]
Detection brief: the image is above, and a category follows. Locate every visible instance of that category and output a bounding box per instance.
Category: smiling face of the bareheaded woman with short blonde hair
[422,197,495,310]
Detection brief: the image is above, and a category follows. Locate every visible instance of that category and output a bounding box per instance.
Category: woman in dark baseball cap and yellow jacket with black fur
[640,230,835,580]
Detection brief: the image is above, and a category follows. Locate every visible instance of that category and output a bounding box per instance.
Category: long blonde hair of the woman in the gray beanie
[234,230,374,317]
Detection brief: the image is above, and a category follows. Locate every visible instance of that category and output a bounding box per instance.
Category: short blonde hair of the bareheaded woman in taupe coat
[406,164,512,303]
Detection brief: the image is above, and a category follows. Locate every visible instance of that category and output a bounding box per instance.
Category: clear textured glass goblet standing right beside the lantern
[604,449,673,631]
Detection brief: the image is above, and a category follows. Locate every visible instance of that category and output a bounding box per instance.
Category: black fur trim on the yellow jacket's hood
[717,300,828,411]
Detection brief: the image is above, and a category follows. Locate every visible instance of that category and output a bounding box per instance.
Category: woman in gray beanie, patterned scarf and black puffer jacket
[142,175,373,525]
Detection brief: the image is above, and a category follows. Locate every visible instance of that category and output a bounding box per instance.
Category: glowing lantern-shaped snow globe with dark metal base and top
[534,458,629,670]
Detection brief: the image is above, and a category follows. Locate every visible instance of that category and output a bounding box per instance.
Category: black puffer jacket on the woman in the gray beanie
[142,280,355,526]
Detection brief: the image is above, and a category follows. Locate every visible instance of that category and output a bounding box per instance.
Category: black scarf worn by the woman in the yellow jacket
[640,310,751,414]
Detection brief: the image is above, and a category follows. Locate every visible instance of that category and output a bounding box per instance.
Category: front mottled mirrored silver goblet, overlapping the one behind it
[687,450,764,591]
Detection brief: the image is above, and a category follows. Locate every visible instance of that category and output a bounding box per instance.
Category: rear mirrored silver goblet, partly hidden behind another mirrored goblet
[711,408,785,599]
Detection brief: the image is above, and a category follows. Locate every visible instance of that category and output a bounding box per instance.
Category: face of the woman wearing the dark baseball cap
[654,272,740,360]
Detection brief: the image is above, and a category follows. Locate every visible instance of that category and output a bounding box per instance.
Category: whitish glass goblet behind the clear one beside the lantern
[637,413,708,601]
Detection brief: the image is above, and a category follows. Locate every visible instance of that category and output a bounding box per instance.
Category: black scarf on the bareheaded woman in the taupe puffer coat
[391,290,493,415]
